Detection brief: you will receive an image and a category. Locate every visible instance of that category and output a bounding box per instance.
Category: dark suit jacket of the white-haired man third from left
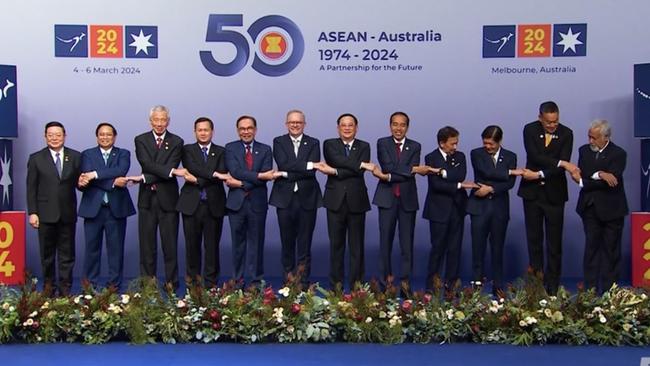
[135,131,183,211]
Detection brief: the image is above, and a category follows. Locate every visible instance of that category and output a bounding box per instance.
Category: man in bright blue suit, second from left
[79,122,135,290]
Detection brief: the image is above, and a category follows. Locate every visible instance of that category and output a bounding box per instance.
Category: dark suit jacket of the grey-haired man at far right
[576,141,629,221]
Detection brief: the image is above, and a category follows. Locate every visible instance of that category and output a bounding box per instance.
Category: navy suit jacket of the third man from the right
[467,147,517,218]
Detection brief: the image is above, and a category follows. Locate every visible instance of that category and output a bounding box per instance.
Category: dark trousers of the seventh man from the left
[327,201,366,289]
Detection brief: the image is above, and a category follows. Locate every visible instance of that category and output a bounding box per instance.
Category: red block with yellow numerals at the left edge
[0,211,25,285]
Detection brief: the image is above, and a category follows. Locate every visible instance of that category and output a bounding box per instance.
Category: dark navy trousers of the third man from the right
[471,201,508,289]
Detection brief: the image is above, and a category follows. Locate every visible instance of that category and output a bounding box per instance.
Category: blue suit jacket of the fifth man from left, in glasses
[226,140,273,212]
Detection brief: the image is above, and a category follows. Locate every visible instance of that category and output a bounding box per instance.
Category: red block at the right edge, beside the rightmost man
[632,212,650,287]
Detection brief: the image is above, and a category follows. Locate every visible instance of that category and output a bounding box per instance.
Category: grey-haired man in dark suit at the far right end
[571,120,629,293]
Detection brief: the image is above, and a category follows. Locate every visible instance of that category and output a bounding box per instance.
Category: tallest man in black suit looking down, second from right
[517,101,578,294]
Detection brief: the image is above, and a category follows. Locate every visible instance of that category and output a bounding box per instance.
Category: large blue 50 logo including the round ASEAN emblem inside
[199,14,305,76]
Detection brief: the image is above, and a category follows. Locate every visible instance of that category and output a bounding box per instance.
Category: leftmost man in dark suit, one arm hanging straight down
[27,121,81,296]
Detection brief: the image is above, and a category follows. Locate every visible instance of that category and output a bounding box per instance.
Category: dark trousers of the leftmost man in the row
[38,221,76,296]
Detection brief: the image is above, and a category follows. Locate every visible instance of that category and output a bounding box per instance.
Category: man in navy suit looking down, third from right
[467,126,523,296]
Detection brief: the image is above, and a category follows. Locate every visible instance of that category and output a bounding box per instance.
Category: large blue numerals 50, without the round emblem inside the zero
[199,14,305,76]
